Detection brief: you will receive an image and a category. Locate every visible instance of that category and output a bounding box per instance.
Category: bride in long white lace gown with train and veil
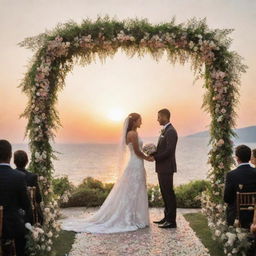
[63,113,153,233]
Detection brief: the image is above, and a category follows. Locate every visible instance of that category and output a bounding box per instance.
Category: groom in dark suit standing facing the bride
[153,109,178,228]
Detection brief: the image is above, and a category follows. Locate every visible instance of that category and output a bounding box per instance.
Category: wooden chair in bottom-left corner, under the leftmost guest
[0,206,16,256]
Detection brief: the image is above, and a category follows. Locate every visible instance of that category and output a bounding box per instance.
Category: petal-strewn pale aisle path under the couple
[61,208,209,256]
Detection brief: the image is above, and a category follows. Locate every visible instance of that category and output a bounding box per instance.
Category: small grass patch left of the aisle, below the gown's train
[53,230,76,256]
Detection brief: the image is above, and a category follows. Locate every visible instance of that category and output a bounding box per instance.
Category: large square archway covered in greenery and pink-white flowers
[20,17,246,255]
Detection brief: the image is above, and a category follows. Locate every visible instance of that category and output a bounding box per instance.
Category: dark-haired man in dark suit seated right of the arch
[224,145,256,228]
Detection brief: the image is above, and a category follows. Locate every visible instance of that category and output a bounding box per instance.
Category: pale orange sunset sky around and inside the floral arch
[0,0,256,143]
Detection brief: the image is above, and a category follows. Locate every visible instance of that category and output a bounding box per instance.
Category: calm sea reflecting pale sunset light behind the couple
[12,137,256,185]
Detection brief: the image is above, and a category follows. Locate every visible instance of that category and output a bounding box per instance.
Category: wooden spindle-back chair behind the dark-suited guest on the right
[236,192,256,226]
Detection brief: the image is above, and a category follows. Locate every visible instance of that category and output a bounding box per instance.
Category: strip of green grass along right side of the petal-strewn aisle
[184,213,225,256]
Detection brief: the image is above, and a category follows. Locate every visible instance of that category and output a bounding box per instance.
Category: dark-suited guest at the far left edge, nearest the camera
[0,140,33,256]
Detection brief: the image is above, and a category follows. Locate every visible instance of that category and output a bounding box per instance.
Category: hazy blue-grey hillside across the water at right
[186,126,256,142]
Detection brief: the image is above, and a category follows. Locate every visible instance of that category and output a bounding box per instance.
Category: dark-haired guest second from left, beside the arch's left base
[14,150,42,223]
